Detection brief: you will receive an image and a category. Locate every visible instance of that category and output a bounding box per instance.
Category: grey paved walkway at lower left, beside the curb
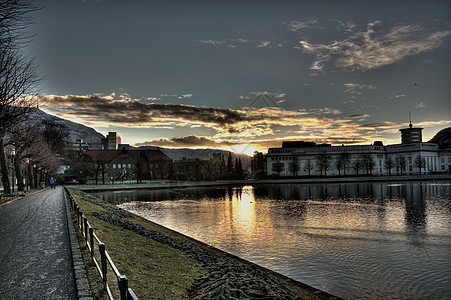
[0,187,77,299]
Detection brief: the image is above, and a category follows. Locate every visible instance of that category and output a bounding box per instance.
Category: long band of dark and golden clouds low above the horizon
[39,91,451,154]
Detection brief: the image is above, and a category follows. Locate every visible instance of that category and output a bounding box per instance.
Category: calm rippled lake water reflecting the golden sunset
[91,182,451,299]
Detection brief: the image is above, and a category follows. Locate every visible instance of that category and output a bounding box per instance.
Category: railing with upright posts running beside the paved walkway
[64,187,138,300]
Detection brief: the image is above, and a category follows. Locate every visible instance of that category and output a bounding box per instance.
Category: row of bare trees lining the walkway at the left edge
[0,0,58,193]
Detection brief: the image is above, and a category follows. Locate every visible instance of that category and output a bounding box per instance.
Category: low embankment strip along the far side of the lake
[70,174,451,192]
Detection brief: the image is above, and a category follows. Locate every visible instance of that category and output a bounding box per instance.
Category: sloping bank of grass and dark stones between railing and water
[70,189,336,299]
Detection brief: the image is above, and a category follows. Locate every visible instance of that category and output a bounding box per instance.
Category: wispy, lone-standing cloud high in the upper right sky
[299,21,451,75]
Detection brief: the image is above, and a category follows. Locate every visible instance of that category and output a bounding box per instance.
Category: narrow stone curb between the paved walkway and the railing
[62,189,94,300]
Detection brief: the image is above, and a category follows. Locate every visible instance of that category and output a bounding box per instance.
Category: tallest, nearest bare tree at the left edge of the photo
[0,0,39,193]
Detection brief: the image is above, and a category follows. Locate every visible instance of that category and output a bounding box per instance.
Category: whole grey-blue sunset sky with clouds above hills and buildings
[25,0,451,154]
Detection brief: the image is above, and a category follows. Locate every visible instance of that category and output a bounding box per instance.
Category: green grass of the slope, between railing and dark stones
[71,190,203,299]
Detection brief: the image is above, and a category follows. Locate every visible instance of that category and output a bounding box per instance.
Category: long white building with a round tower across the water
[264,124,451,177]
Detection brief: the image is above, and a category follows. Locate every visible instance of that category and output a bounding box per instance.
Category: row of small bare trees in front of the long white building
[272,153,426,177]
